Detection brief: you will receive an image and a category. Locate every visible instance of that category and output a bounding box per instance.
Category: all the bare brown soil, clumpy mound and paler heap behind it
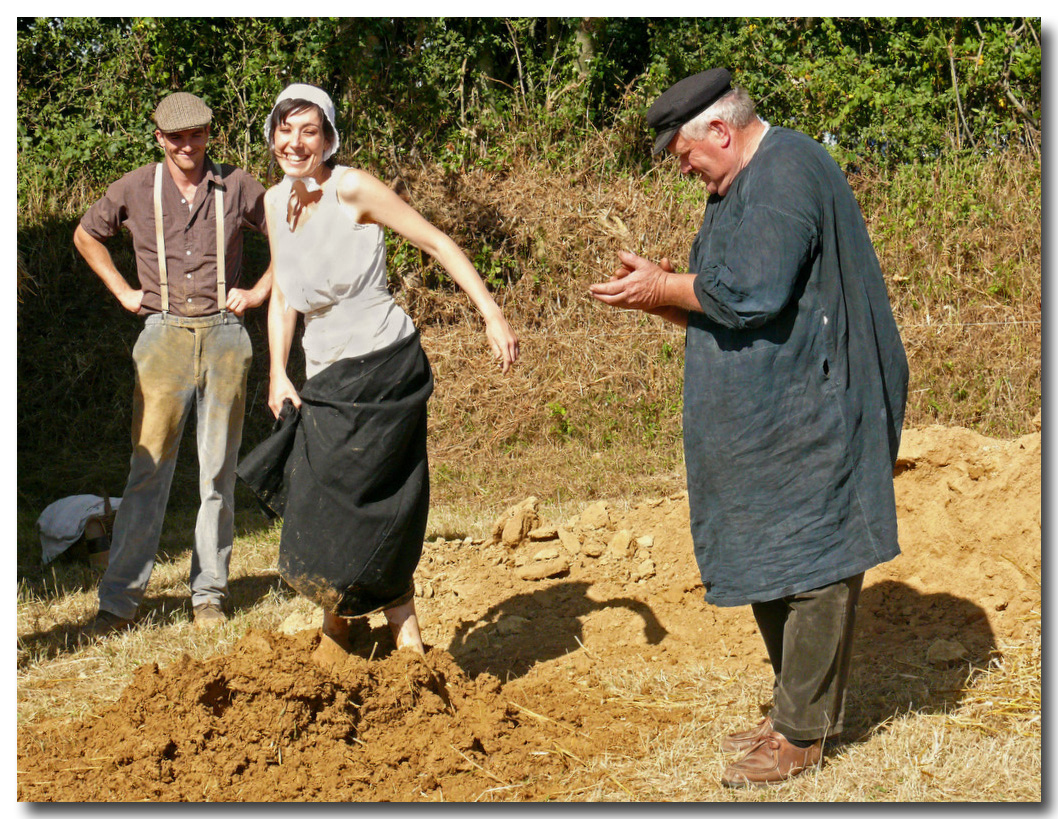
[18,427,1041,801]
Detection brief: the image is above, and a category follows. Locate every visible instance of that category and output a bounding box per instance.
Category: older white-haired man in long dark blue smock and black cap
[590,69,908,787]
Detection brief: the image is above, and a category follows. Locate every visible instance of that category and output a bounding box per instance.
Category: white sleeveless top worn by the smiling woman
[273,165,415,378]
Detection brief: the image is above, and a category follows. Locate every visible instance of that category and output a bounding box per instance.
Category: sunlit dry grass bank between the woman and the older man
[385,144,704,513]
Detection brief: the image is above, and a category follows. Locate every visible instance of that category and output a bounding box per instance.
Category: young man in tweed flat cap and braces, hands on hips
[74,92,272,636]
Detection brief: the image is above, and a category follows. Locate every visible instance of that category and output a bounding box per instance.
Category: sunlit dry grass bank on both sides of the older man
[382,141,1042,516]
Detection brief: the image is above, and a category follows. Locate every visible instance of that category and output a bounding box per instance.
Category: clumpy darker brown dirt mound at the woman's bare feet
[19,631,622,801]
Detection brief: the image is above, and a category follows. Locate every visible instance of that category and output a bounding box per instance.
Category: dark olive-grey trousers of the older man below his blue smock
[752,572,863,740]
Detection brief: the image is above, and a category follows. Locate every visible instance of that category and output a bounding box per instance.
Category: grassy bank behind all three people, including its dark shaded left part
[18,143,1042,522]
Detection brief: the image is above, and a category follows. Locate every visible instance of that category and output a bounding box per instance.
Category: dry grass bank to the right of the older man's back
[854,154,1042,437]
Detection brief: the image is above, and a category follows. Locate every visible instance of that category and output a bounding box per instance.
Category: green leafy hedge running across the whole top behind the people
[17,17,1042,203]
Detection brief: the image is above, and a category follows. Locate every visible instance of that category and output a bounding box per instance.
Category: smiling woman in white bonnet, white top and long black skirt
[239,85,518,653]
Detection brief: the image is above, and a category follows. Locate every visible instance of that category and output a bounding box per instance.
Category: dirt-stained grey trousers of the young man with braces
[99,313,252,619]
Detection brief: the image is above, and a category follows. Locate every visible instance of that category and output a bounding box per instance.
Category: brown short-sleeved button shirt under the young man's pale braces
[80,160,267,316]
